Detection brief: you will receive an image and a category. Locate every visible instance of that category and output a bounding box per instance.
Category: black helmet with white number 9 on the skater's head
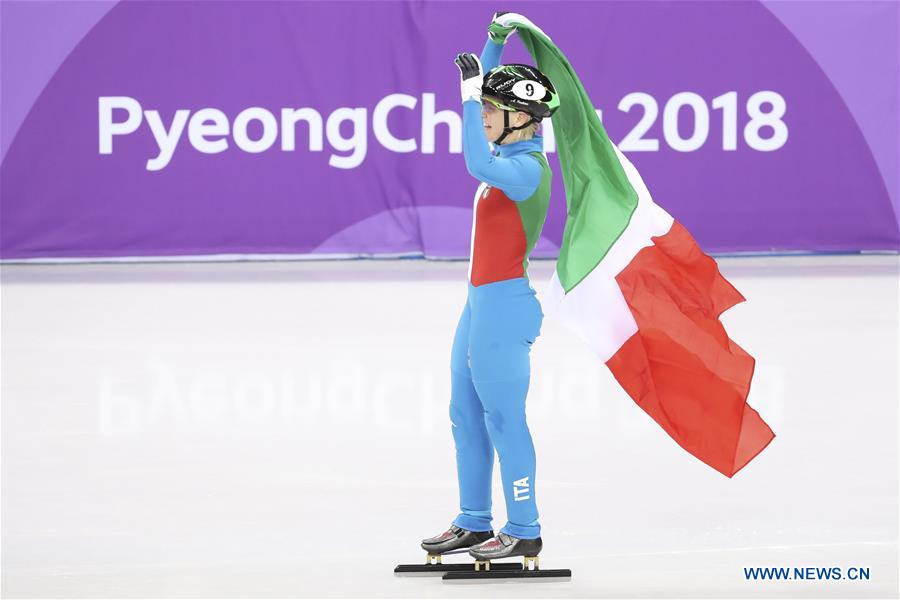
[481,64,559,123]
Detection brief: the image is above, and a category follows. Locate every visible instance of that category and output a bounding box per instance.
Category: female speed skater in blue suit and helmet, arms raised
[422,13,559,562]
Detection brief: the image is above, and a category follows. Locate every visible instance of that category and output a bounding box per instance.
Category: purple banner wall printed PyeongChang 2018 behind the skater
[0,0,900,260]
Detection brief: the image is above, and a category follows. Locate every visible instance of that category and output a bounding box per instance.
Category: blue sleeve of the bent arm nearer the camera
[463,99,542,202]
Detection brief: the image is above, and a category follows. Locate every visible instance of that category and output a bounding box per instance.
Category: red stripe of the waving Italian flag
[606,221,775,477]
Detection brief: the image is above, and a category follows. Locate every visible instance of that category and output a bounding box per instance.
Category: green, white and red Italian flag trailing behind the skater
[510,13,775,477]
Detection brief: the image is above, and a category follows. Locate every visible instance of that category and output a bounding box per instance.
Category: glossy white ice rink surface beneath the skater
[2,256,900,598]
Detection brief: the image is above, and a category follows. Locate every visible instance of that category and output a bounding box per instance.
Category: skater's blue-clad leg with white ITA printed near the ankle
[470,279,543,539]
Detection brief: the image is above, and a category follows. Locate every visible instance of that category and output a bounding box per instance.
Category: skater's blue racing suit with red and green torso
[450,39,551,539]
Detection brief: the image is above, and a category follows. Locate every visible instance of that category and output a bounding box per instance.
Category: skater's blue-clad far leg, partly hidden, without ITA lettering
[450,302,494,531]
